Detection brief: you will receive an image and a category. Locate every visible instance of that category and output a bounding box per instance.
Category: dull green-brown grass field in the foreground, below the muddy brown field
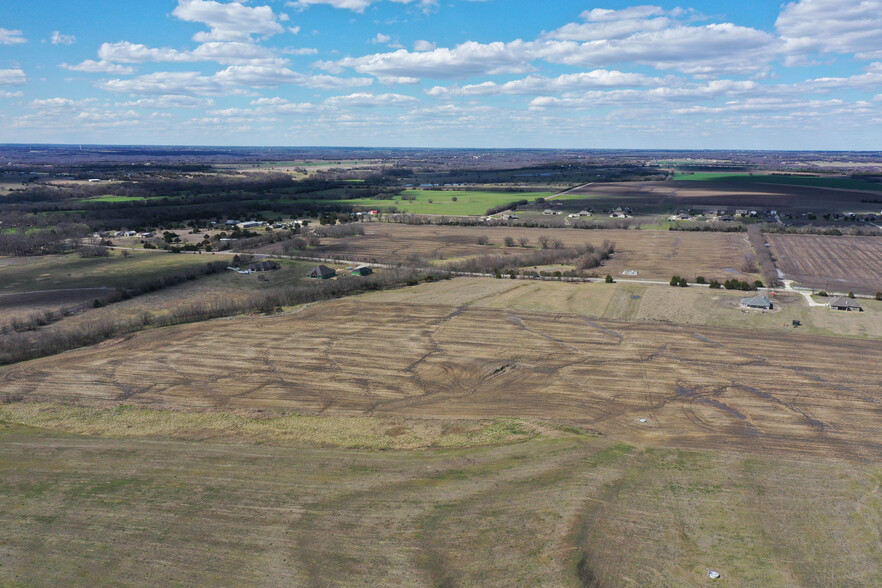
[0,424,882,587]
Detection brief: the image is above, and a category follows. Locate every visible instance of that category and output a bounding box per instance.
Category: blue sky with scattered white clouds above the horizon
[0,0,882,150]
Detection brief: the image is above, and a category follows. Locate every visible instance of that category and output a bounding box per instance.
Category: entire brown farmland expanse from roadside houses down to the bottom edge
[0,276,882,587]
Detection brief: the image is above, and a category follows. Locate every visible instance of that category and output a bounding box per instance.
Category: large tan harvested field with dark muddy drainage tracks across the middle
[0,296,882,460]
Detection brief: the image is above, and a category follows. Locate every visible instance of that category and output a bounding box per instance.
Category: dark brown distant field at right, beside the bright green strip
[568,181,882,213]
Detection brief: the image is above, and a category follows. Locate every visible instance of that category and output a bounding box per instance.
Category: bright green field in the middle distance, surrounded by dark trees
[326,190,553,216]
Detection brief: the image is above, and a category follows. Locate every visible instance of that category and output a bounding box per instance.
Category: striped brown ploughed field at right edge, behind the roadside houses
[766,234,882,294]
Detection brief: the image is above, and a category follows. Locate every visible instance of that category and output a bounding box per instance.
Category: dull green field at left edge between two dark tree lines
[0,251,223,294]
